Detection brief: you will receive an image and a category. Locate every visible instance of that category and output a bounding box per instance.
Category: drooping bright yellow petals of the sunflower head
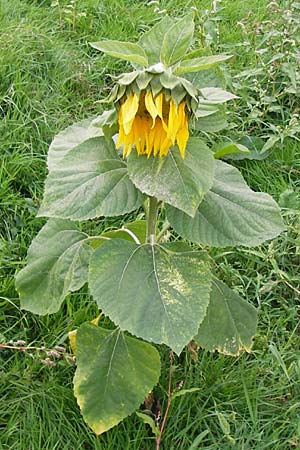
[116,90,189,158]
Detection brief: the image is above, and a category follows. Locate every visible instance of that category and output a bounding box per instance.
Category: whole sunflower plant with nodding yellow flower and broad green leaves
[16,15,284,440]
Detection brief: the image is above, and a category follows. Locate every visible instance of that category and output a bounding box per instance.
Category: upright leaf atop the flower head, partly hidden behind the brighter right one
[139,16,174,65]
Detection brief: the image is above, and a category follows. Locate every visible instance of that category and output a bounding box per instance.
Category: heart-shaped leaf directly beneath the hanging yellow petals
[128,137,215,217]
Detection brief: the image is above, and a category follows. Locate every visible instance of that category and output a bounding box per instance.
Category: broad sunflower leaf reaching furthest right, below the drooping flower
[167,160,285,247]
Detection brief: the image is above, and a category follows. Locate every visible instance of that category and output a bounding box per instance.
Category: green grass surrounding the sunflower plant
[0,0,300,450]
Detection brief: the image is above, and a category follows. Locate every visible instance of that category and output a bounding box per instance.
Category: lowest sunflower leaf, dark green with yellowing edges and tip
[74,323,160,434]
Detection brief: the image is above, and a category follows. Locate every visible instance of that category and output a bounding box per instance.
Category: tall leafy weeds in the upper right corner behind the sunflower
[203,0,300,157]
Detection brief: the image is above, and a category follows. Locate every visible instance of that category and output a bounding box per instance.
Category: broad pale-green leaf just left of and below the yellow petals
[39,137,143,220]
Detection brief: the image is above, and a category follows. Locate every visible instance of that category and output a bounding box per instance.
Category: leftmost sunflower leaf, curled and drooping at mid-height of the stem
[16,219,93,314]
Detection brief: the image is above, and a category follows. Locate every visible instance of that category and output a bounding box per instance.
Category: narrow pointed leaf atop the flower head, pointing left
[90,40,148,67]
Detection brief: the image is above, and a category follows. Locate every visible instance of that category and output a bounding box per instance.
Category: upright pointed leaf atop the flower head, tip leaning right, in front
[160,14,194,67]
